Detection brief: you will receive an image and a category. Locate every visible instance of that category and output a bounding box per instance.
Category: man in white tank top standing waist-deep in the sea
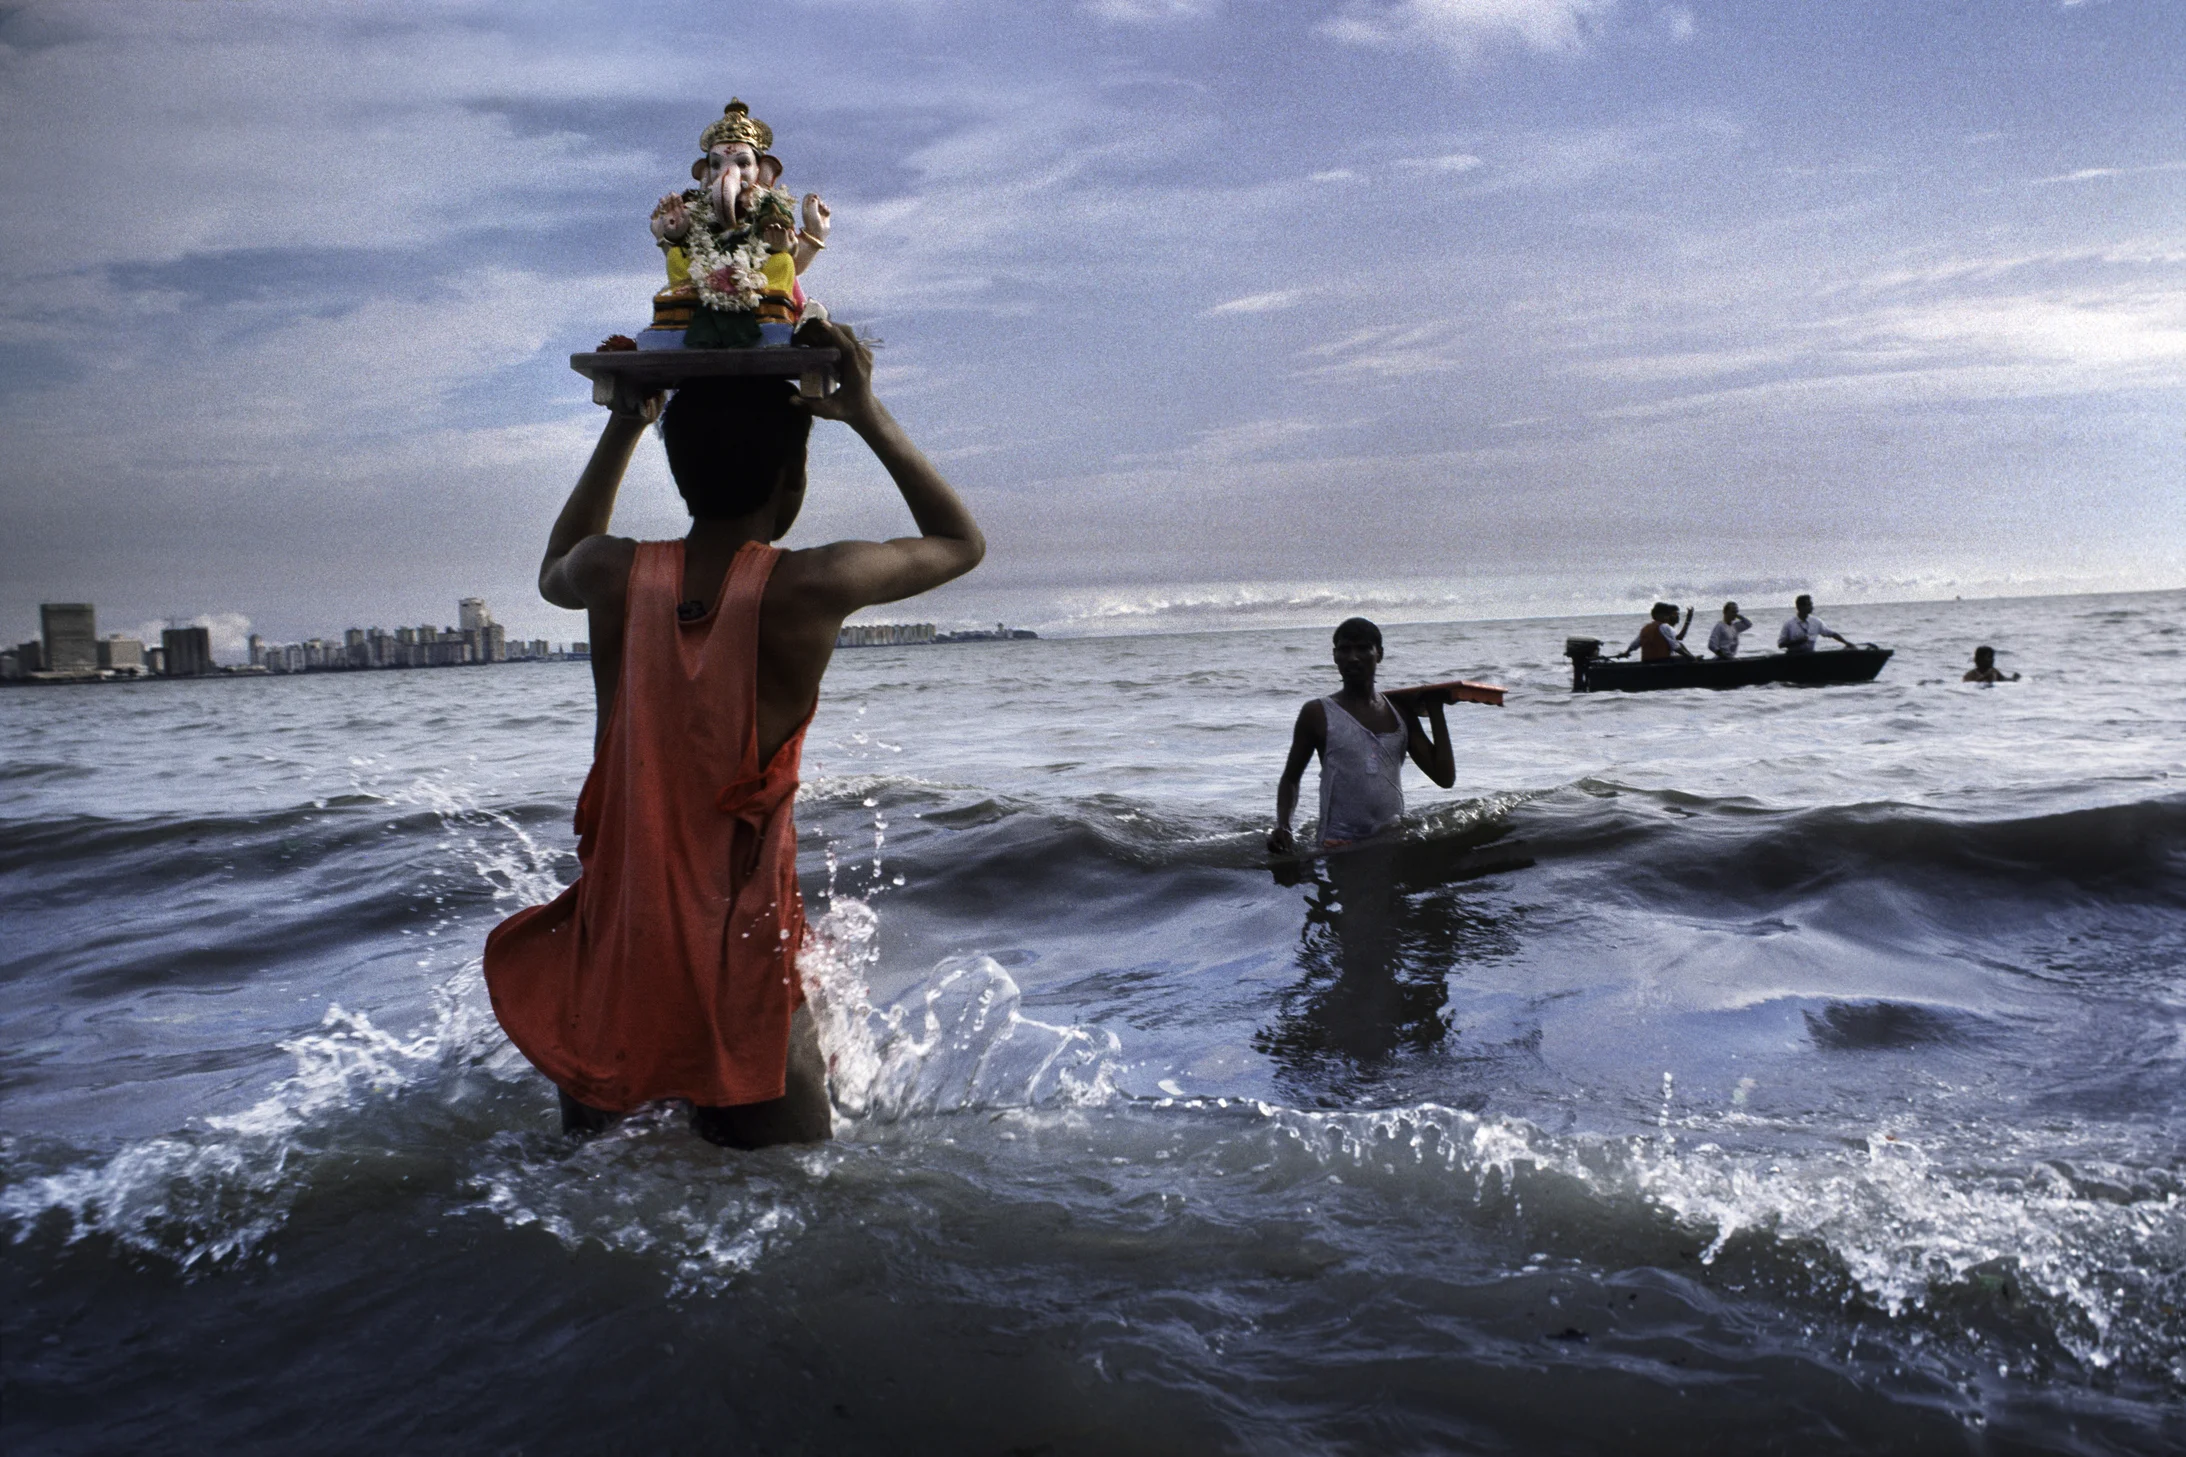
[1268,618,1458,854]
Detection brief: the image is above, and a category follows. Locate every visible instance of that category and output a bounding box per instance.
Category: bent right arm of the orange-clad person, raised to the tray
[798,323,986,616]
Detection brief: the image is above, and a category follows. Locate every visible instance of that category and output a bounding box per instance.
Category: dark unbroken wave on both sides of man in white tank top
[868,780,2186,913]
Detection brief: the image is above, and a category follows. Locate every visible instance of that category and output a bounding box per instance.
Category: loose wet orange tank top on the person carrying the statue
[485,542,811,1112]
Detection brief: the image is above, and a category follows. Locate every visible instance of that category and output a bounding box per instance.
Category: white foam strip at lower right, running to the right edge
[1259,1103,2186,1383]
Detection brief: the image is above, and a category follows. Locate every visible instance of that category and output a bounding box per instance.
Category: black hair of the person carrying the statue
[660,376,813,520]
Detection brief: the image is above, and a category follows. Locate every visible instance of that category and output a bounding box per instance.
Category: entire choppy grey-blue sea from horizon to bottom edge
[0,594,2186,1453]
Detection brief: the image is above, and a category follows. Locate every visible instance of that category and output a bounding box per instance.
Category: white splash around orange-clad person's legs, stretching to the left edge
[0,899,1119,1293]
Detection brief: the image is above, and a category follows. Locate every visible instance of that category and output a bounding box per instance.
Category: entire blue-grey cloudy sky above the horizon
[0,0,2186,640]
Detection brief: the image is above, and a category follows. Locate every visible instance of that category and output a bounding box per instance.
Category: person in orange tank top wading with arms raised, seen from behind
[485,323,986,1149]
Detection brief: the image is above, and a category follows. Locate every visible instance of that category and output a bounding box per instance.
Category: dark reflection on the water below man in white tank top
[1253,826,1532,1107]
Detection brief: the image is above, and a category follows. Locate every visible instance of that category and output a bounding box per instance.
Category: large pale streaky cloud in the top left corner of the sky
[0,4,675,277]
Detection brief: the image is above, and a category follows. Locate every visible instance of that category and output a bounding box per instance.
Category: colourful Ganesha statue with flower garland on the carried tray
[638,100,833,350]
